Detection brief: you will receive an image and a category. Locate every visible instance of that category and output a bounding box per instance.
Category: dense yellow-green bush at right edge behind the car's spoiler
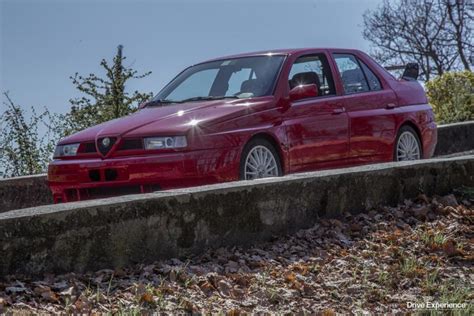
[426,71,474,124]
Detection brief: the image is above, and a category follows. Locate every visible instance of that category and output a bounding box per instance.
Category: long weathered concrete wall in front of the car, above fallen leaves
[0,156,474,278]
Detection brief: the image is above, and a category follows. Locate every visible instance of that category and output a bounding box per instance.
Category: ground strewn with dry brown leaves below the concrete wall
[0,188,474,315]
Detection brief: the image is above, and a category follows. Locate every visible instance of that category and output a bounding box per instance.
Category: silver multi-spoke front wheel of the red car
[239,138,283,180]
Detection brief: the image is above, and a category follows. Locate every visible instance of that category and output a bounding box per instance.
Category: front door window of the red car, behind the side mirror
[288,54,336,96]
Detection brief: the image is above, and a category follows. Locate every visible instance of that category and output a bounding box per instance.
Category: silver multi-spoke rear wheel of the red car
[393,125,423,161]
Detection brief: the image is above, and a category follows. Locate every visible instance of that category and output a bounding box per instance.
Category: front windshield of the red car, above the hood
[153,55,284,103]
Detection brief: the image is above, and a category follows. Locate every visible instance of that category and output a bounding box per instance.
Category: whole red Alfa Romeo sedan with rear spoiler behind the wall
[48,49,437,203]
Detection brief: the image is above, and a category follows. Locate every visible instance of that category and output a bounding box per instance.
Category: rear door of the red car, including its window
[332,52,398,163]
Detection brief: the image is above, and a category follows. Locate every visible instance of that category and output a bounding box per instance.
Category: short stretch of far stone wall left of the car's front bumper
[0,174,53,213]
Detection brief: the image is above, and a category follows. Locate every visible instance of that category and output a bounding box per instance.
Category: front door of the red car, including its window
[284,53,349,172]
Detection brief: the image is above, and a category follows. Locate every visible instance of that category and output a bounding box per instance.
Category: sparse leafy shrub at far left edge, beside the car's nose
[0,93,57,177]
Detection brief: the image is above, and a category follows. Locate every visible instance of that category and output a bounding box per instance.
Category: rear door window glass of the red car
[334,54,382,94]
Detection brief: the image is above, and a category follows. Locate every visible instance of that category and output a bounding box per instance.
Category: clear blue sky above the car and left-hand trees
[0,0,380,112]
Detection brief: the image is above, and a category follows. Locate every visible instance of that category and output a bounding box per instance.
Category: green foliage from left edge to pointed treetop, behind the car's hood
[0,46,151,177]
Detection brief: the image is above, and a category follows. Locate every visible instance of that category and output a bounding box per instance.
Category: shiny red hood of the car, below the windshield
[59,97,274,144]
